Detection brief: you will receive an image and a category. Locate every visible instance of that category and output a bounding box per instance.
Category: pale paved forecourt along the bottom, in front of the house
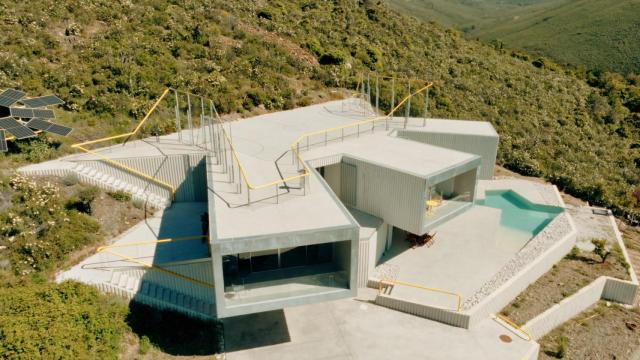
[224,289,538,360]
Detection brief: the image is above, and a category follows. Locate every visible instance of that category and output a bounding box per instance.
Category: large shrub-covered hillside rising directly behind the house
[0,0,640,221]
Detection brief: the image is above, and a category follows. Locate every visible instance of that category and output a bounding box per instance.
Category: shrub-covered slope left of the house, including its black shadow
[0,174,223,359]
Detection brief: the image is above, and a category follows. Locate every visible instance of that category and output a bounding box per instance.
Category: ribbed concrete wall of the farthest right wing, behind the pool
[396,129,498,179]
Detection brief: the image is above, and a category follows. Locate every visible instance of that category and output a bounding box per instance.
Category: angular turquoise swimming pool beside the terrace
[476,190,563,248]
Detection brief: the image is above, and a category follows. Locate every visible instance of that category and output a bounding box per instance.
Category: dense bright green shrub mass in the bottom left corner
[0,282,127,359]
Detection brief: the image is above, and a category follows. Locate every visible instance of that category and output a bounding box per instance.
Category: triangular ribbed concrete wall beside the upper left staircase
[78,154,207,202]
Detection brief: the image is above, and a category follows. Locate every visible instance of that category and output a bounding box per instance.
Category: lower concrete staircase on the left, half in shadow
[98,269,215,319]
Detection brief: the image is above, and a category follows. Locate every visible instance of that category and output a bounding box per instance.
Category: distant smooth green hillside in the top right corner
[389,0,640,73]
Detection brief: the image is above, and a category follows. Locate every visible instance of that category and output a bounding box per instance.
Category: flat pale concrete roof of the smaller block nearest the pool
[301,133,480,179]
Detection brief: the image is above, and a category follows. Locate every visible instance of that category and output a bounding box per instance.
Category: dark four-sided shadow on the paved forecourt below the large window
[222,310,291,352]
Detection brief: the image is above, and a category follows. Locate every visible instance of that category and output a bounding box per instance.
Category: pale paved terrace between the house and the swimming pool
[377,205,519,309]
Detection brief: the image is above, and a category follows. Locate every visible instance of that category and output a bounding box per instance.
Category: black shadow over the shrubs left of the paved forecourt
[126,301,224,356]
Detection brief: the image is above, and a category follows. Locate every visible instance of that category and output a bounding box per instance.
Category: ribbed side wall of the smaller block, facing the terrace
[341,157,427,234]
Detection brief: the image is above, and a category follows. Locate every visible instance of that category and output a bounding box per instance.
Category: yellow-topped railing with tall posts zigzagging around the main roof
[72,74,433,206]
